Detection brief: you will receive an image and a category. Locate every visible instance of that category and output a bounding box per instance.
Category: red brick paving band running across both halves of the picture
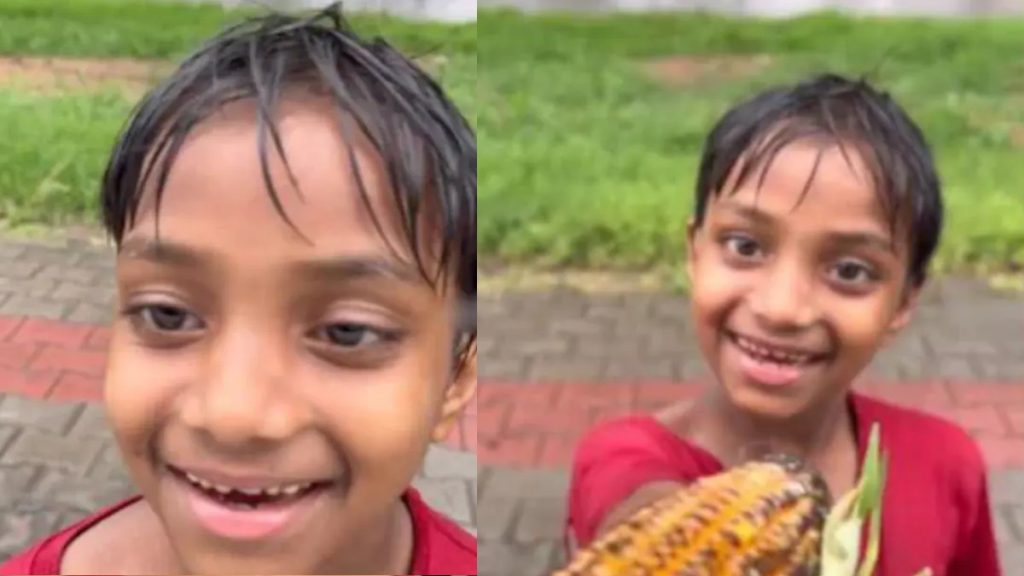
[0,309,1024,469]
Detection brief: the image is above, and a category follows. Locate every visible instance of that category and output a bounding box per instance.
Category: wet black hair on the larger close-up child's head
[101,3,476,360]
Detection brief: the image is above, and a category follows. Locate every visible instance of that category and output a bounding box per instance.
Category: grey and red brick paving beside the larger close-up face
[0,238,477,562]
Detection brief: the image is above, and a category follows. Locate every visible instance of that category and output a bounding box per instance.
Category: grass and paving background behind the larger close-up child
[0,0,477,563]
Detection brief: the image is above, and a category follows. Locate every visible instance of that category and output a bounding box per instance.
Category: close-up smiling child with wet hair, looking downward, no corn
[0,6,476,574]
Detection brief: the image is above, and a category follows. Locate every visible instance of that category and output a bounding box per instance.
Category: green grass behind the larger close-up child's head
[0,0,476,227]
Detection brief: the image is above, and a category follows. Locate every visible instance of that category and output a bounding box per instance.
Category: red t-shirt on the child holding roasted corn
[568,395,1000,576]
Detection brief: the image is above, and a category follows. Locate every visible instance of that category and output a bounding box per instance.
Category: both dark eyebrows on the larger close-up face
[119,238,425,284]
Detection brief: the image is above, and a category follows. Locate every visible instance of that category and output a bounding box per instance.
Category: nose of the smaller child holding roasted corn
[750,256,818,331]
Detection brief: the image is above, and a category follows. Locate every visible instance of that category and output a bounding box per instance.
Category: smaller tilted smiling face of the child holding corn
[689,142,915,418]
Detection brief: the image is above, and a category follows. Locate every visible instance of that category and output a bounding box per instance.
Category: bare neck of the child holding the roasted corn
[700,388,853,465]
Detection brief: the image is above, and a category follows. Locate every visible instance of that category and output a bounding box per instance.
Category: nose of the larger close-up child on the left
[182,327,309,446]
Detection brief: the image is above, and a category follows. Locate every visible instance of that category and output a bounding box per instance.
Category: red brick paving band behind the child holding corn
[477,381,1024,470]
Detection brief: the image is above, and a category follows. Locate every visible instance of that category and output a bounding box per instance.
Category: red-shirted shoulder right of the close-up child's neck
[406,489,476,574]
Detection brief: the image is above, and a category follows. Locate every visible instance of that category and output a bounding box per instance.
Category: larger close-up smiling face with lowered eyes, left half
[105,96,476,574]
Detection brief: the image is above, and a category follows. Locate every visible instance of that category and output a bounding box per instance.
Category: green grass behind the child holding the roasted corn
[478,12,1024,270]
